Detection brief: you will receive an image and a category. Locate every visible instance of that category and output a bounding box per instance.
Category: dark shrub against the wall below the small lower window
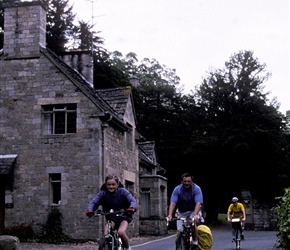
[38,208,71,244]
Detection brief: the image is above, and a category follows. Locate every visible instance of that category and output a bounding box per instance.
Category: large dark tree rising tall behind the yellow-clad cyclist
[188,51,286,222]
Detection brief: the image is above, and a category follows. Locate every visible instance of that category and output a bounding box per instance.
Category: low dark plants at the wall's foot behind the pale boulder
[2,222,34,242]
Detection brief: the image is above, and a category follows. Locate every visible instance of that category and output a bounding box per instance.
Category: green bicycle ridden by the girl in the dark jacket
[94,209,125,250]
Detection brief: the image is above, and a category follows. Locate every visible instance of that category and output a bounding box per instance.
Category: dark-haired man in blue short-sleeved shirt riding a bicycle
[167,173,203,249]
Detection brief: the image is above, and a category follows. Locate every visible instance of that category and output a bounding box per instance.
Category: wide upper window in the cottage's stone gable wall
[42,104,77,135]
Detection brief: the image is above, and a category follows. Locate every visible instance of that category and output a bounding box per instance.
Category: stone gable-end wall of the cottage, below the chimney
[0,54,106,237]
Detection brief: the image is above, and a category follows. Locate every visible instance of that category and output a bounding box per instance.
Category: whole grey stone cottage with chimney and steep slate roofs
[0,1,167,239]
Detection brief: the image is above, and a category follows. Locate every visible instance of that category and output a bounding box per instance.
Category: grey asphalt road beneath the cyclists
[132,226,277,250]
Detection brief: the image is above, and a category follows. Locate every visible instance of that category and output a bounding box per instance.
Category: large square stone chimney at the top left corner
[3,0,46,59]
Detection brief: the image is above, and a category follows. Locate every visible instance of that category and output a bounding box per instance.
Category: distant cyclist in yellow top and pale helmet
[227,197,246,240]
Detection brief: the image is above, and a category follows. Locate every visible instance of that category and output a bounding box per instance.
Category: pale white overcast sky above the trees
[70,0,290,114]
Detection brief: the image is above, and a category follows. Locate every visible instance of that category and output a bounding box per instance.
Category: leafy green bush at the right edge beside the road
[273,187,290,250]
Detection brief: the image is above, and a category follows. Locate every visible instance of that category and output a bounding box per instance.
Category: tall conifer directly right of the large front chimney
[45,0,75,54]
